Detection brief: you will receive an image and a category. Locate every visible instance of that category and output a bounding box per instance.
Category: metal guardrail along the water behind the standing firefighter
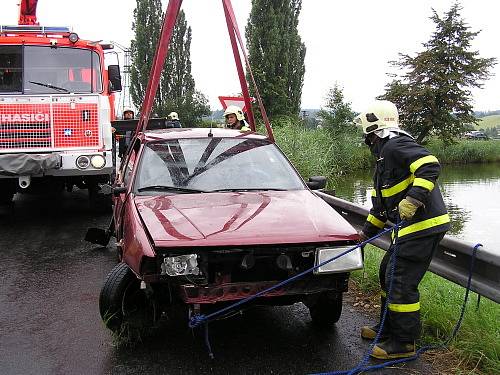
[315,192,500,303]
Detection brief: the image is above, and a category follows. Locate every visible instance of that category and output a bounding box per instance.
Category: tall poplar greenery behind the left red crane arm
[130,0,210,126]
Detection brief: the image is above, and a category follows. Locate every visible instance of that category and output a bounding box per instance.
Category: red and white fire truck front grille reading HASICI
[0,97,102,152]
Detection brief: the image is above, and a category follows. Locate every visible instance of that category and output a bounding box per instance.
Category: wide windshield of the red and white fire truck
[0,45,103,95]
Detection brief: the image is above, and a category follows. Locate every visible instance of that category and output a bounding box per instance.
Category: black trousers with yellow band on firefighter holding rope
[379,233,444,341]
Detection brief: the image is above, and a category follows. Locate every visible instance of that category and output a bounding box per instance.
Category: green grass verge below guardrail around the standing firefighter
[353,246,500,374]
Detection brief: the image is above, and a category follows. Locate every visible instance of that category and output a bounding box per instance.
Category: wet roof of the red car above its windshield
[141,128,268,142]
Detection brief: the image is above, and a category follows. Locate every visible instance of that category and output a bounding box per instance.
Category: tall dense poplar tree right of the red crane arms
[245,0,306,117]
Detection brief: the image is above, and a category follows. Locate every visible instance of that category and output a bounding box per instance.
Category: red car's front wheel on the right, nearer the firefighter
[308,292,342,327]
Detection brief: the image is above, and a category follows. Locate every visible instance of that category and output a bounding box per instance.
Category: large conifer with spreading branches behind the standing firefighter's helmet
[380,3,496,143]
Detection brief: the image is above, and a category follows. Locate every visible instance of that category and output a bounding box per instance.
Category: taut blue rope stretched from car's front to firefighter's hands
[188,222,402,328]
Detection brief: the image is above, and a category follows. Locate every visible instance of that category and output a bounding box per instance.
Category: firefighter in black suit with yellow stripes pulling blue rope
[355,100,450,359]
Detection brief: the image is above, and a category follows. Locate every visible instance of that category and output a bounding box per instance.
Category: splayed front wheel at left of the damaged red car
[99,263,157,334]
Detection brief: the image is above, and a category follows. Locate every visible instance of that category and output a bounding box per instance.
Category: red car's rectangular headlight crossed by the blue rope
[314,246,363,274]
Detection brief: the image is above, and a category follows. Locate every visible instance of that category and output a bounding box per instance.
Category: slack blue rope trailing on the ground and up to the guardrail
[314,243,483,375]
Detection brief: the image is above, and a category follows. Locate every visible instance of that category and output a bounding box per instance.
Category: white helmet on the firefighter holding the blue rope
[354,100,399,135]
